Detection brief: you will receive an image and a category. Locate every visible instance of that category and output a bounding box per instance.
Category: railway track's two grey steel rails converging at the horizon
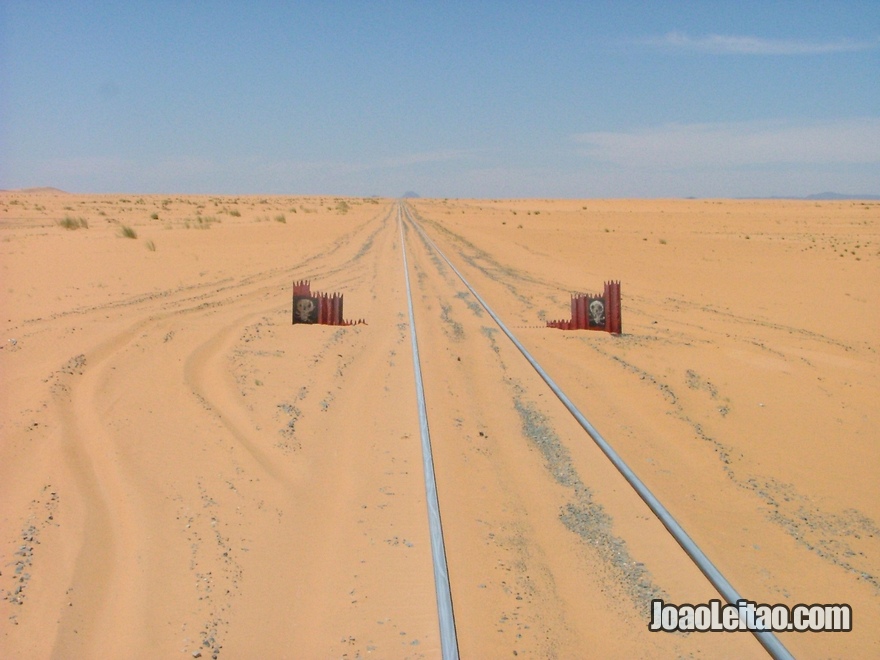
[397,203,793,660]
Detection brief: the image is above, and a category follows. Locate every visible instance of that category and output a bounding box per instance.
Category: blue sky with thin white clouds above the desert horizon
[0,0,880,198]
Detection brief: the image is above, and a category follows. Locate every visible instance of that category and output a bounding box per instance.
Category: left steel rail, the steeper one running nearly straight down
[397,206,458,660]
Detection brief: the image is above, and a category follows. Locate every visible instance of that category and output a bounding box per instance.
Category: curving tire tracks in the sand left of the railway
[34,205,396,656]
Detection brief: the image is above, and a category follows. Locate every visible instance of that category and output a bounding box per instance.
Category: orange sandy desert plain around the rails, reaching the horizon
[0,191,880,658]
